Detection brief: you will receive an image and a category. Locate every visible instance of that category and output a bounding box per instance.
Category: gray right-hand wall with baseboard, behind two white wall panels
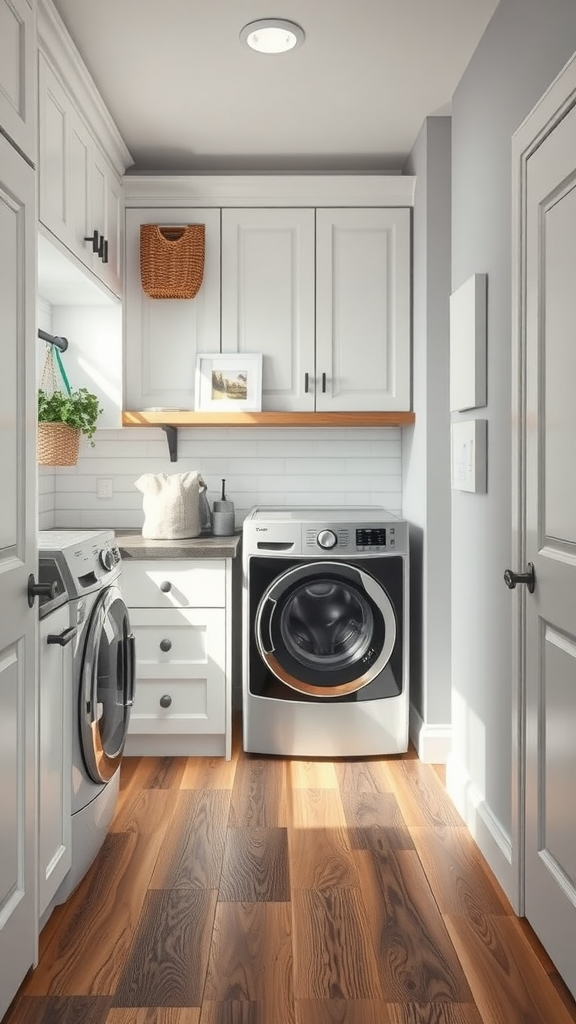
[448,0,576,893]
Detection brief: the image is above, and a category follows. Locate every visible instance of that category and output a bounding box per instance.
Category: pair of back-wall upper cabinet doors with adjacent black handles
[222,208,411,412]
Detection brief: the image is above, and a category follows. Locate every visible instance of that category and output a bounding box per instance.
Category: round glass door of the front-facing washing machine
[255,561,397,697]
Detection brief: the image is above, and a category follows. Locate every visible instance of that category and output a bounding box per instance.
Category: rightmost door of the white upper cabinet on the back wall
[316,209,410,412]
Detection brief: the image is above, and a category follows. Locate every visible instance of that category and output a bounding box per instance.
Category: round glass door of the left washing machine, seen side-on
[80,586,135,782]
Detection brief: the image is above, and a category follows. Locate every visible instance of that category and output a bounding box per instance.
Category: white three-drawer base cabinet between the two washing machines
[122,558,232,759]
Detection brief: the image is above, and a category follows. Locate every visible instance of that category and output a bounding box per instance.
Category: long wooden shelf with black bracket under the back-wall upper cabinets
[122,409,415,462]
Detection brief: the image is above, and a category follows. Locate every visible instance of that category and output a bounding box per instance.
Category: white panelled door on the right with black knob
[512,59,576,995]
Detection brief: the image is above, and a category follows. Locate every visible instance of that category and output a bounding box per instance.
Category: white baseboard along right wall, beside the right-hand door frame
[446,753,510,913]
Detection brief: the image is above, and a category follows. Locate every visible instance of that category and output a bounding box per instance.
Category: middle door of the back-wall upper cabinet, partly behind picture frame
[222,209,315,411]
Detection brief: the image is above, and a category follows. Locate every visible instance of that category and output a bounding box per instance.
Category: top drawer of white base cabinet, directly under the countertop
[121,558,225,608]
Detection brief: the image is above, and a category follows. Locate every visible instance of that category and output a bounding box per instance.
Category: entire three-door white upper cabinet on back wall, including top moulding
[124,175,414,414]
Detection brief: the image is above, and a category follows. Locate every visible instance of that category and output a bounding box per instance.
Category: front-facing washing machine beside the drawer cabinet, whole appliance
[242,506,409,758]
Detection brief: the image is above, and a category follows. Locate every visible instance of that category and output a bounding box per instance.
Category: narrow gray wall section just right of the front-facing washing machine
[403,117,451,760]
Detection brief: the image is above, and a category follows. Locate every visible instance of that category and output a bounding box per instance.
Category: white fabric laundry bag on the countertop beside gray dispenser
[134,470,207,541]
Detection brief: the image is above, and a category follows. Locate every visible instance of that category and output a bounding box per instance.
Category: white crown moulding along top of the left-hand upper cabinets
[38,0,134,177]
